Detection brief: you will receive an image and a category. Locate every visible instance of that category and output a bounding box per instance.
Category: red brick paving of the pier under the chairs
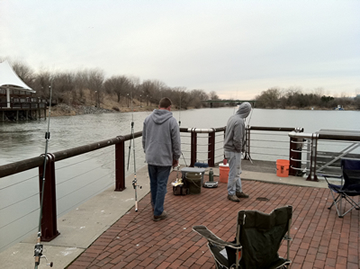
[68,172,360,269]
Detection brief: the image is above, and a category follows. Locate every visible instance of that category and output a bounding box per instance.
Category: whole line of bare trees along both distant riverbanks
[4,58,360,110]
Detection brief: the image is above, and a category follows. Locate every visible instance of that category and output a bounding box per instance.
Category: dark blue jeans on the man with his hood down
[148,164,171,216]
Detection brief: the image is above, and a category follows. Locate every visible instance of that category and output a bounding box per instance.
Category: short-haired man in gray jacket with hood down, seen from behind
[142,97,181,221]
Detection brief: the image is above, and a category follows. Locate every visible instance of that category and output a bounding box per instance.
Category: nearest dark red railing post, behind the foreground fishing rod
[39,153,60,242]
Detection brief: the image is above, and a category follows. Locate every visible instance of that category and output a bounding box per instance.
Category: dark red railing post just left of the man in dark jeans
[115,138,126,191]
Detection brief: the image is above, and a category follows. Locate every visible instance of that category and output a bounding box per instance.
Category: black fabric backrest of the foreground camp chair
[236,206,292,268]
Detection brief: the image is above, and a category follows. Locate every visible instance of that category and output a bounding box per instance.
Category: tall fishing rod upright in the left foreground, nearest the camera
[34,81,53,269]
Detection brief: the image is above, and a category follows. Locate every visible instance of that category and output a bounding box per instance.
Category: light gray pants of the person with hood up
[224,151,242,195]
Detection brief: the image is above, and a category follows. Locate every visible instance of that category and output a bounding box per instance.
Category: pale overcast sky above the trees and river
[0,0,360,99]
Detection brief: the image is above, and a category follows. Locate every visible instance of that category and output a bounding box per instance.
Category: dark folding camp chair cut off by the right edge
[318,159,360,218]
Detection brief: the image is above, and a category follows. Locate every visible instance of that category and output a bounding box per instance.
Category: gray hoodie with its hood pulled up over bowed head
[224,102,251,152]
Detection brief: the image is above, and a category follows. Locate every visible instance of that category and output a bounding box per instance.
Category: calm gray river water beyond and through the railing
[0,108,360,251]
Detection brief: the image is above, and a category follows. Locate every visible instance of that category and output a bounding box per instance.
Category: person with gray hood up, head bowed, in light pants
[224,102,251,202]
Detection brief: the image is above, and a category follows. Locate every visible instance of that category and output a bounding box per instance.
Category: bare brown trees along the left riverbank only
[7,62,221,109]
